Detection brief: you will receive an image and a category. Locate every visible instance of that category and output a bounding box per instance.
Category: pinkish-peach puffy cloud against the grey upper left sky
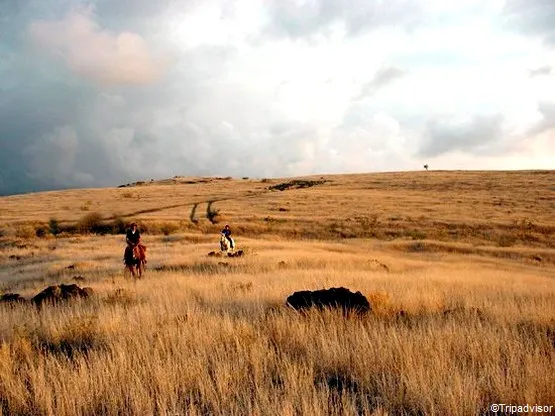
[27,8,169,84]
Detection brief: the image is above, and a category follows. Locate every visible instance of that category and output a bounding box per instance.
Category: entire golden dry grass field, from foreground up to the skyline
[0,171,555,415]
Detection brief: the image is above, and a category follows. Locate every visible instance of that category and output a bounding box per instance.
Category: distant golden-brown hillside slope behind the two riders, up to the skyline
[0,171,555,248]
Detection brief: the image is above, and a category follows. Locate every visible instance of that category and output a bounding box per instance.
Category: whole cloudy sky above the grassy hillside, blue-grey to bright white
[0,0,555,195]
